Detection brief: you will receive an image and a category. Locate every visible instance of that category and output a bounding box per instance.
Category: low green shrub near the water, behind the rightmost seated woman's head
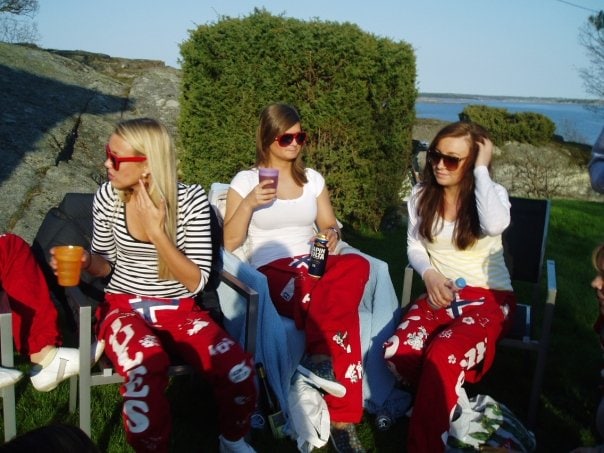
[459,105,556,145]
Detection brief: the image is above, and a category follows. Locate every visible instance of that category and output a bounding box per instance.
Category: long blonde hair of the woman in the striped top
[113,118,178,280]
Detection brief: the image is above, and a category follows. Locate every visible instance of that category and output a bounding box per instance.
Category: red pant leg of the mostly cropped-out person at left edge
[0,234,61,355]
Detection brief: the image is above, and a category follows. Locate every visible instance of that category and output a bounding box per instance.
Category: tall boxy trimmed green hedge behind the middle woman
[179,10,417,229]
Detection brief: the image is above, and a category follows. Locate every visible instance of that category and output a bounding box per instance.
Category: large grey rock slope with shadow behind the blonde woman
[0,43,180,243]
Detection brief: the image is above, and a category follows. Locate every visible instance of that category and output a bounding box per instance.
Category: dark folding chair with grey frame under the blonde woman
[32,193,258,435]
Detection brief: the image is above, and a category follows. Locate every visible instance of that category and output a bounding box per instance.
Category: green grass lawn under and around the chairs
[0,200,604,452]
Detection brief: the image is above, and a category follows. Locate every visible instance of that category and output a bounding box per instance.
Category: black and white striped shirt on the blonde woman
[91,183,212,298]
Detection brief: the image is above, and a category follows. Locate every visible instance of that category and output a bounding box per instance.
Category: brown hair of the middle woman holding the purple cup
[256,103,308,186]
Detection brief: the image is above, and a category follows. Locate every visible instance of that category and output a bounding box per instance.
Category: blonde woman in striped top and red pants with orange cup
[52,118,256,452]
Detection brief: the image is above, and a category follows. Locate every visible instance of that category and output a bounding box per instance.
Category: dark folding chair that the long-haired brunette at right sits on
[401,197,557,428]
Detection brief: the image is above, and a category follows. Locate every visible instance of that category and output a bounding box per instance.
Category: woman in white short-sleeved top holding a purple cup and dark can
[224,104,369,452]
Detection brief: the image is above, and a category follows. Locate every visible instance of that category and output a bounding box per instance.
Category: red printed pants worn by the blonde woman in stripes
[98,294,256,452]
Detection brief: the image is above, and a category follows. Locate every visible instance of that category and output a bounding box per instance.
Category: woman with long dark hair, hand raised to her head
[384,122,516,452]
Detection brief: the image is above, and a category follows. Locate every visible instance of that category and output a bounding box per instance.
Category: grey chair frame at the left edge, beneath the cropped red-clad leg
[0,288,17,442]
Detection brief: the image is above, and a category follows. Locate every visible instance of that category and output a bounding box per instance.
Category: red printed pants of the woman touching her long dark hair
[384,287,516,453]
